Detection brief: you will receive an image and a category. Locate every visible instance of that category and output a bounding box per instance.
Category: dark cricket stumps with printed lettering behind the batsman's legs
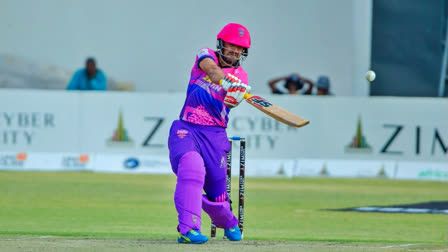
[210,137,246,238]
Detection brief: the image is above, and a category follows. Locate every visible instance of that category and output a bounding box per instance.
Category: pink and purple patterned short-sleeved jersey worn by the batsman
[180,48,248,128]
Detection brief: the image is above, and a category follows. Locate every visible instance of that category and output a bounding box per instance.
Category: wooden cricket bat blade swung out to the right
[244,93,310,128]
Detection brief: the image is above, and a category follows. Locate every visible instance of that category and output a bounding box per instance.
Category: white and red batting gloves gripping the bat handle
[220,74,251,108]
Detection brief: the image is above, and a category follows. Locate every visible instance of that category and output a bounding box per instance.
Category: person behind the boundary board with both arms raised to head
[269,74,313,95]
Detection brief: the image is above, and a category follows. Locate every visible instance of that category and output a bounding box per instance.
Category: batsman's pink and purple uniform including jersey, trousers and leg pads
[168,48,248,234]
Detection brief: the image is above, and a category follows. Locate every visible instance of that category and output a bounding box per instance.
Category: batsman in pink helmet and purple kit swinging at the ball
[168,23,251,244]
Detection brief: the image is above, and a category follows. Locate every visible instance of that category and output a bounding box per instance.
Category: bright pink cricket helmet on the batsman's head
[216,23,250,49]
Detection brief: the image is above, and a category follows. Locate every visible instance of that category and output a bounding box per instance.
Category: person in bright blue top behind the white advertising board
[67,58,106,90]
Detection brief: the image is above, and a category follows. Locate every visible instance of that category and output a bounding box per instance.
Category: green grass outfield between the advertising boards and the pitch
[0,172,448,248]
